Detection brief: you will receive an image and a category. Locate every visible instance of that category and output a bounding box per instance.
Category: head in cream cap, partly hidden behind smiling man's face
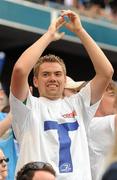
[63,76,87,97]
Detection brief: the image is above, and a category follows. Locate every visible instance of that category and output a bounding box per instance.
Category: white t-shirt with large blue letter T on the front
[10,84,99,180]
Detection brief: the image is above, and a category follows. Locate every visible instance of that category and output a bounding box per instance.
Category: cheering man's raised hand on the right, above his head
[61,10,83,33]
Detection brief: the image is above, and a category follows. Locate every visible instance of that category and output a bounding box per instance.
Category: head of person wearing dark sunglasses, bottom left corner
[0,148,9,180]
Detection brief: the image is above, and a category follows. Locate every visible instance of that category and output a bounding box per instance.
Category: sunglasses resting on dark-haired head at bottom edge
[21,162,56,176]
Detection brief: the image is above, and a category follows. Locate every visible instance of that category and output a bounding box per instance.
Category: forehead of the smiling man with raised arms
[40,62,63,72]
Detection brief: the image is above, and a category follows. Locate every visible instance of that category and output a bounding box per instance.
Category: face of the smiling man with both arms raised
[34,62,66,100]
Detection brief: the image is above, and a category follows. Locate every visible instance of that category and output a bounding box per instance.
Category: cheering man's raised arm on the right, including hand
[61,10,113,104]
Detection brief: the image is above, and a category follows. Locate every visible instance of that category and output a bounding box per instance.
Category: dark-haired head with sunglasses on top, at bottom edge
[16,161,56,180]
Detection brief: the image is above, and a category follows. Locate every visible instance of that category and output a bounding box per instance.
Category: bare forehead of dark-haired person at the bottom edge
[32,170,55,180]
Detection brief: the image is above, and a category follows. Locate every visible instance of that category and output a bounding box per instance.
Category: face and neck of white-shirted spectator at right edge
[95,80,117,116]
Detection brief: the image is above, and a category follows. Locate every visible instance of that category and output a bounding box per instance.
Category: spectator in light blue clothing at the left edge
[0,93,17,180]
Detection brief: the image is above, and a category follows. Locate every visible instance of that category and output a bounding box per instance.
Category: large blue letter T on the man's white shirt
[44,120,79,173]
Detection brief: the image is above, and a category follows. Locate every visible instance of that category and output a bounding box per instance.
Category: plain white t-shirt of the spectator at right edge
[88,115,115,180]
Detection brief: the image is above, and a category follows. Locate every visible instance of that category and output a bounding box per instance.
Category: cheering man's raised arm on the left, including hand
[11,17,64,101]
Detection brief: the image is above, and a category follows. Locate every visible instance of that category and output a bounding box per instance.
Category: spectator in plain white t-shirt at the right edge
[87,81,117,180]
